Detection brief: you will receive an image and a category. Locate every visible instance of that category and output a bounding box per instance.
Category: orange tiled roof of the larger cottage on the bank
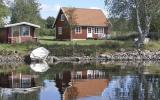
[54,7,109,26]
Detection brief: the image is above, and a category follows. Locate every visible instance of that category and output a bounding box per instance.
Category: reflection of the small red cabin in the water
[0,71,41,100]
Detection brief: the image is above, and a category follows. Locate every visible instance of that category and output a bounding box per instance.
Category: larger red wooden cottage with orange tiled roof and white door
[54,7,110,40]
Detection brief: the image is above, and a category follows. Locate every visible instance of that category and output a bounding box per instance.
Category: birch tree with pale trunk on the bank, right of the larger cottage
[105,0,160,47]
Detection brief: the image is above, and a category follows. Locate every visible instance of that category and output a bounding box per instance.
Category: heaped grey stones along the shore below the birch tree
[98,50,160,61]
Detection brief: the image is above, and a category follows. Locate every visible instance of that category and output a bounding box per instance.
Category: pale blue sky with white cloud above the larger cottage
[39,0,108,19]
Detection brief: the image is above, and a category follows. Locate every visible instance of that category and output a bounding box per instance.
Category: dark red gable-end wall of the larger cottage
[56,11,70,40]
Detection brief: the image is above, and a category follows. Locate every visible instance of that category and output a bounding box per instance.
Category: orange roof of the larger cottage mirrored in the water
[64,79,109,100]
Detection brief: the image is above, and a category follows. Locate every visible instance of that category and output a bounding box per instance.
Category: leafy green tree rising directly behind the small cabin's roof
[11,0,41,24]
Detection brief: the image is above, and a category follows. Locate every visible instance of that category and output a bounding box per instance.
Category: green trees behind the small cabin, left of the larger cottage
[0,0,55,36]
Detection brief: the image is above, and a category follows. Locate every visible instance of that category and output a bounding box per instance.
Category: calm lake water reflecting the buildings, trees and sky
[0,62,160,100]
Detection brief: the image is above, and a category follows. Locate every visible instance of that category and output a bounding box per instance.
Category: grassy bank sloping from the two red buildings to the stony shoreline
[0,36,160,56]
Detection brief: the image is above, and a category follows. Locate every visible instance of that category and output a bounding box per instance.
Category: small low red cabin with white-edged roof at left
[0,22,40,43]
